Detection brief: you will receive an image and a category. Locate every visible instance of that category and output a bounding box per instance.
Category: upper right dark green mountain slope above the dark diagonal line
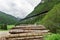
[27,0,60,17]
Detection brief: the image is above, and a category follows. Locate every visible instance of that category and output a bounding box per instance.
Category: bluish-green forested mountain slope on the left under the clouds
[0,11,17,24]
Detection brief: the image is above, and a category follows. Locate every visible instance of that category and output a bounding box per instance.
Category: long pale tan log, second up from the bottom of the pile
[5,33,42,38]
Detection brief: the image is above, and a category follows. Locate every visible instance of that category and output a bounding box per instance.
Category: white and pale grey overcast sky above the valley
[0,0,41,18]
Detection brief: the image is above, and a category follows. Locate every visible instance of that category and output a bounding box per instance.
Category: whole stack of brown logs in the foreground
[0,25,49,40]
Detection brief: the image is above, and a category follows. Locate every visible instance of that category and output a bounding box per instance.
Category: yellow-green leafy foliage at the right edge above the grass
[40,4,60,33]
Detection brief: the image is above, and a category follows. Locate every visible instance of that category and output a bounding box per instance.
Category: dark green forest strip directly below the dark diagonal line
[19,14,46,24]
